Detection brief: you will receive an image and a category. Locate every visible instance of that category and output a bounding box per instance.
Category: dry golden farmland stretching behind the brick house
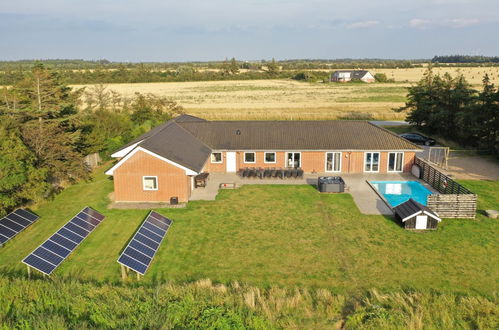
[75,67,499,120]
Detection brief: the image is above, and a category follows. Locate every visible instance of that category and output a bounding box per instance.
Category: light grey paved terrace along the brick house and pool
[190,173,434,215]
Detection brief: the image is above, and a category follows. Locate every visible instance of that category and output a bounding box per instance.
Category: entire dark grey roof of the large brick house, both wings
[114,115,419,172]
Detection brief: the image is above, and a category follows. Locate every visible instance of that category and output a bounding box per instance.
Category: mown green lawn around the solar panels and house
[0,169,499,294]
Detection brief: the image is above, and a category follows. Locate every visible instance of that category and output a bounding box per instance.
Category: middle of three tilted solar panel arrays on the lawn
[23,207,105,275]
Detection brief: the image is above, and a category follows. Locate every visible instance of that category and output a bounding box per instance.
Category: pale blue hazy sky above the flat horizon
[0,0,499,62]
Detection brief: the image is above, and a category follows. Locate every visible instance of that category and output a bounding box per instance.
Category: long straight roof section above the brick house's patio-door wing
[179,120,419,151]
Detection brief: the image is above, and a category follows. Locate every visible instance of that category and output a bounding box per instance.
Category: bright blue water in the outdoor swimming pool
[371,181,432,207]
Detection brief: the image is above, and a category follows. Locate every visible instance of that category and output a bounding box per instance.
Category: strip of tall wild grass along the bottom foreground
[0,276,499,329]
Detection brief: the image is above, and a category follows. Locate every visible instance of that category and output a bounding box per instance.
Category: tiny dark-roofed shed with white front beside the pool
[393,198,442,230]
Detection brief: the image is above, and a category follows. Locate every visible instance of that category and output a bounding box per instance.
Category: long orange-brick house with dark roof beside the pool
[106,115,420,202]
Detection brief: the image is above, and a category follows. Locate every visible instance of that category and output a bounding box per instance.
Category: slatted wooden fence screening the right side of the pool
[415,157,477,218]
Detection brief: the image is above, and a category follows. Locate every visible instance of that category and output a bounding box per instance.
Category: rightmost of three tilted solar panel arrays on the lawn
[118,211,173,275]
